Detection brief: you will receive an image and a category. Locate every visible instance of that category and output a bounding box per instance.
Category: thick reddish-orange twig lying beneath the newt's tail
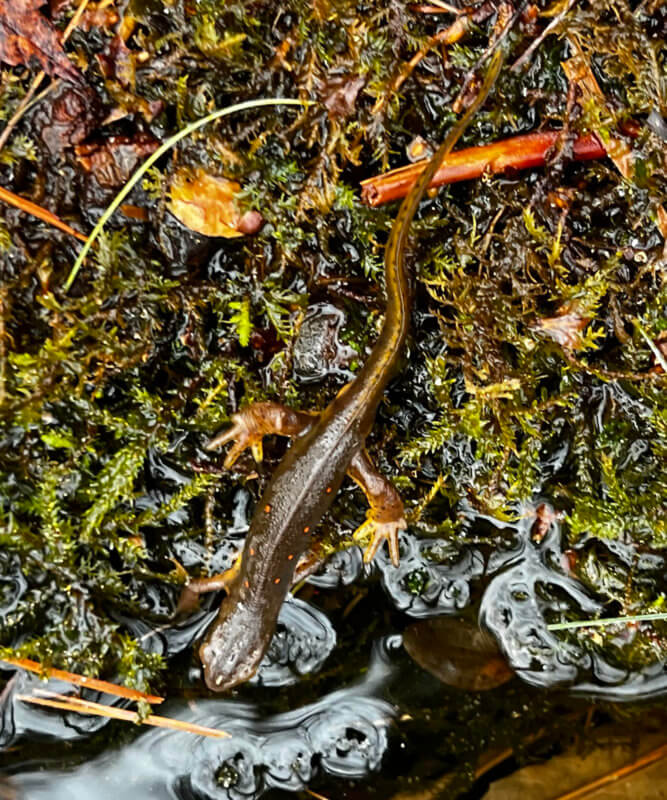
[361,131,607,206]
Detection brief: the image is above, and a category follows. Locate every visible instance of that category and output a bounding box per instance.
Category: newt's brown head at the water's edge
[199,598,270,692]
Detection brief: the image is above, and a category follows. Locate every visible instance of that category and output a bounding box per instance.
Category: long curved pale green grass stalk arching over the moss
[63,97,310,292]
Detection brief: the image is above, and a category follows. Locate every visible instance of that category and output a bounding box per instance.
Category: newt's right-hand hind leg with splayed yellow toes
[348,450,407,567]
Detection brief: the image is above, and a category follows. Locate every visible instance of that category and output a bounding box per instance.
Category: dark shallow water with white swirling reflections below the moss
[0,504,667,800]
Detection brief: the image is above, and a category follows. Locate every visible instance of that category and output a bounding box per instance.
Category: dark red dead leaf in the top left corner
[0,0,83,86]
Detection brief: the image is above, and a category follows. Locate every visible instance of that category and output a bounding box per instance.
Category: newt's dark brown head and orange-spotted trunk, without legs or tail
[199,372,404,691]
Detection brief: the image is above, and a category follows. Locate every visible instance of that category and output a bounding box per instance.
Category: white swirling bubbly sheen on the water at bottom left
[6,637,400,800]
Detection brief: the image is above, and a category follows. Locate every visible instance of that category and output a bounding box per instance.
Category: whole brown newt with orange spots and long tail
[189,57,501,692]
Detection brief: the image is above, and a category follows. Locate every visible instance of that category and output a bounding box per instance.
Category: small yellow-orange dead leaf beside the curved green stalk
[169,169,263,239]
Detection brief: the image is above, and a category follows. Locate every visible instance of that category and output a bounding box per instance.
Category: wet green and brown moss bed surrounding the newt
[0,0,667,700]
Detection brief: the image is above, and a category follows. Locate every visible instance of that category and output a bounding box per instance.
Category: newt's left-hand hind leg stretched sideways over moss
[206,402,314,469]
